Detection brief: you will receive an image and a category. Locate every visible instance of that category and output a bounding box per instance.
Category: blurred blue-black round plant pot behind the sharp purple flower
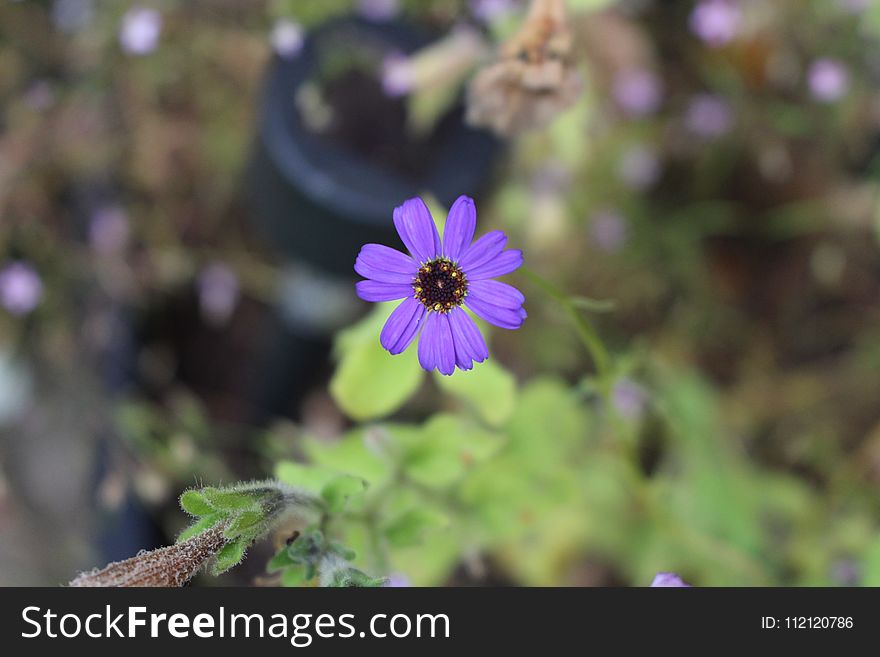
[248,19,498,276]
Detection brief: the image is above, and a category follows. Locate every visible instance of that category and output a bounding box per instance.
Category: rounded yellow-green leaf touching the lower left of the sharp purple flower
[330,304,424,421]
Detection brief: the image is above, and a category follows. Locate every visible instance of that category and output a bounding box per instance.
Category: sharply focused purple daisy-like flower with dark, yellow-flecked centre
[354,196,526,375]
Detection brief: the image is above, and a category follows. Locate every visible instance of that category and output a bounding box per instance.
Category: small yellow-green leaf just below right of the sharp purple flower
[436,360,517,427]
